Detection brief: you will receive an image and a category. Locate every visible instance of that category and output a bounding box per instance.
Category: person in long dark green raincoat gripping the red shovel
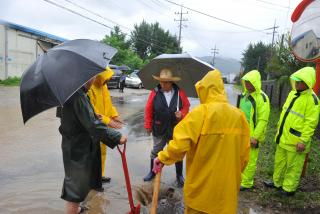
[59,78,127,214]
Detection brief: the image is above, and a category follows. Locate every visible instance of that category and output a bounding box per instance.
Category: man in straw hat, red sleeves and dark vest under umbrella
[143,69,190,187]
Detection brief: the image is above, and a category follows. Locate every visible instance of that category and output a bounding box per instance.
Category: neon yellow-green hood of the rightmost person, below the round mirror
[290,67,316,90]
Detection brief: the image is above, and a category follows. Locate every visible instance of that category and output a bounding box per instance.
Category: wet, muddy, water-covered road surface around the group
[0,86,250,214]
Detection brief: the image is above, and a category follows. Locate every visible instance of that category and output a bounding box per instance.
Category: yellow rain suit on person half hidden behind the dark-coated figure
[88,67,118,176]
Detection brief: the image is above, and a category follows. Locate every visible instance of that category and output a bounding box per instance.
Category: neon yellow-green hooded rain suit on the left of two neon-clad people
[240,70,270,188]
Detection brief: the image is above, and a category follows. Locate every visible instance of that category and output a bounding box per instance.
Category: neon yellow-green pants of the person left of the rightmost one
[241,148,259,188]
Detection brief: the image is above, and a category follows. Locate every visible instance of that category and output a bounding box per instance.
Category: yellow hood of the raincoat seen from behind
[195,69,227,104]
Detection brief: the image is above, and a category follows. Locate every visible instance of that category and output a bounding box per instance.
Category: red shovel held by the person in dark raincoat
[117,143,141,214]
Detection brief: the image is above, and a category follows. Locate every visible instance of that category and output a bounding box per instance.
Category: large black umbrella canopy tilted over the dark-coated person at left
[20,39,117,123]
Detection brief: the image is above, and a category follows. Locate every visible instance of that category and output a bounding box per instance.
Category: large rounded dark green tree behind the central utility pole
[131,20,182,60]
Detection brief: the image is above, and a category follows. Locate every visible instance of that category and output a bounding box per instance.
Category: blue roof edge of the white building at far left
[0,19,68,42]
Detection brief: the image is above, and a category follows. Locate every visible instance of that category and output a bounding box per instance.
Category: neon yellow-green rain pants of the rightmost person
[273,145,306,192]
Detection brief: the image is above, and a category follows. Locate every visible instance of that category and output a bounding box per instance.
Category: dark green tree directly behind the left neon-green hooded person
[241,41,271,79]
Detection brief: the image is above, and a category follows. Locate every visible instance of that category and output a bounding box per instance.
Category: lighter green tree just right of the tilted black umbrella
[102,26,143,69]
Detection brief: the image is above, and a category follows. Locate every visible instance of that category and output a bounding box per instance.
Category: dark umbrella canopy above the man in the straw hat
[138,53,214,97]
